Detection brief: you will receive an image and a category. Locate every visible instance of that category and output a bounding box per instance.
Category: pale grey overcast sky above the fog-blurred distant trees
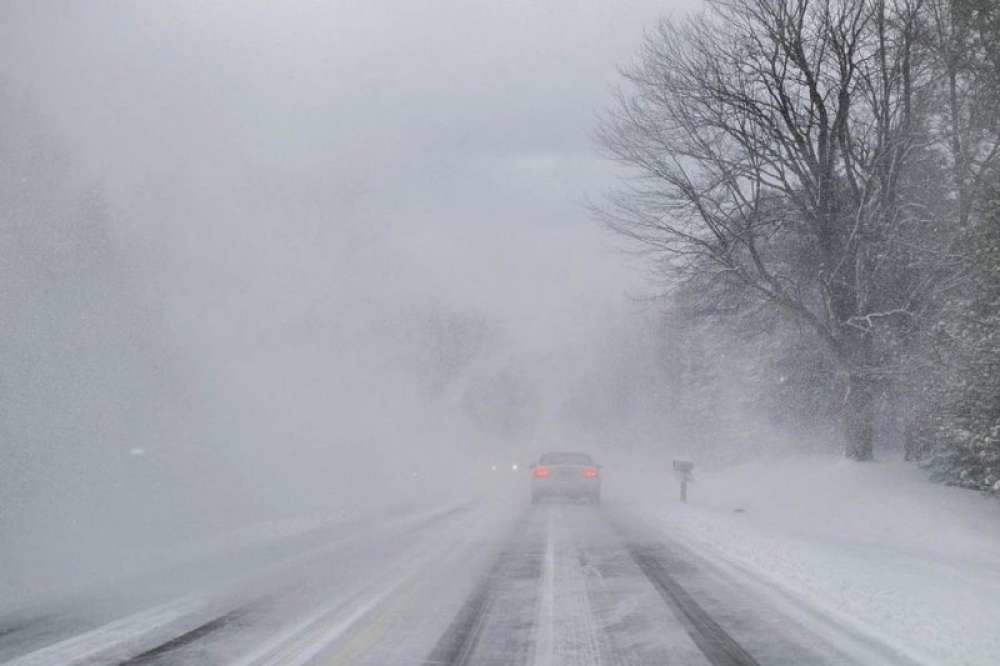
[0,0,698,426]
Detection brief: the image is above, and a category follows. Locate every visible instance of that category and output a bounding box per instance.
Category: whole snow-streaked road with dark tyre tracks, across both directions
[0,501,911,666]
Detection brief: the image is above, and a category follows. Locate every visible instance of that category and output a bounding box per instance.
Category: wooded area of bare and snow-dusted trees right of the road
[598,0,1000,491]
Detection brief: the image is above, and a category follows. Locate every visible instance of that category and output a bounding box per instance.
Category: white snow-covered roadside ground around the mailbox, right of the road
[630,455,1000,666]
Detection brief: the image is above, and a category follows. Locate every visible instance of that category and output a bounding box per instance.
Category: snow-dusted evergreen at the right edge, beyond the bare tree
[901,0,1000,492]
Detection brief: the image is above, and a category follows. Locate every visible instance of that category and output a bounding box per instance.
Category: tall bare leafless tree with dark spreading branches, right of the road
[599,0,936,460]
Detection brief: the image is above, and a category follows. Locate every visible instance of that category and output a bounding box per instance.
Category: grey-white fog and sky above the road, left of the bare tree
[0,0,728,605]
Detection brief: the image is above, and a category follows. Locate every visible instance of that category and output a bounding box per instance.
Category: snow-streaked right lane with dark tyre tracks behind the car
[282,504,892,666]
